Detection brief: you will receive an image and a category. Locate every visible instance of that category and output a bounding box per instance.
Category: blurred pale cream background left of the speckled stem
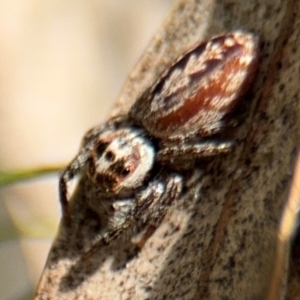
[0,0,174,300]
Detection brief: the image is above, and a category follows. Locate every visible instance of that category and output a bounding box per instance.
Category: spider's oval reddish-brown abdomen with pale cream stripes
[130,32,258,139]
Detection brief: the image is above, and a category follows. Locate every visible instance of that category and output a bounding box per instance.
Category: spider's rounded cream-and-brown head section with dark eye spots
[86,128,155,194]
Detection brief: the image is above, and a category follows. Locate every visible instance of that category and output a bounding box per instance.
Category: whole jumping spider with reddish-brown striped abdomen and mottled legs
[60,31,258,253]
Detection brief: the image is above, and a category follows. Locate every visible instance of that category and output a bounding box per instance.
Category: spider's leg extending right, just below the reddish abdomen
[156,139,234,169]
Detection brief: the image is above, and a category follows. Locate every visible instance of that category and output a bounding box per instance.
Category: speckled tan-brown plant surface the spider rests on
[35,0,300,300]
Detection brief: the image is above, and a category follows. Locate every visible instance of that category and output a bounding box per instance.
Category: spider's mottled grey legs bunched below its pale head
[84,174,182,259]
